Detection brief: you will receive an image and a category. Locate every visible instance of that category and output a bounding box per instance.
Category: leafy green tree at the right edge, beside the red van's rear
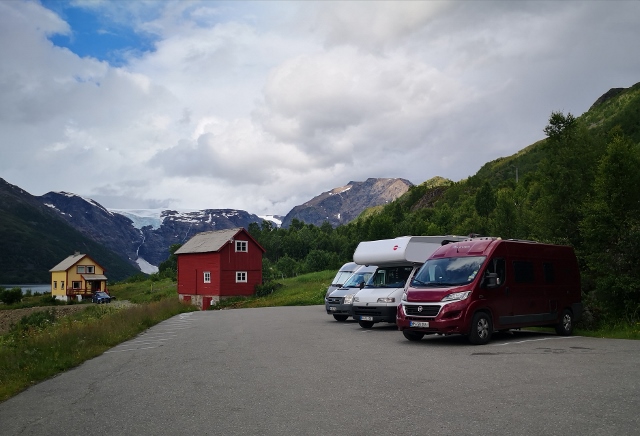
[580,132,640,322]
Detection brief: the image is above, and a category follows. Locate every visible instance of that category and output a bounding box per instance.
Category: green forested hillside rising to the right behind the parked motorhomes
[244,83,640,322]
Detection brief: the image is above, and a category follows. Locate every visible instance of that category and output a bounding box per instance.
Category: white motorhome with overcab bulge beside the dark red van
[352,236,466,328]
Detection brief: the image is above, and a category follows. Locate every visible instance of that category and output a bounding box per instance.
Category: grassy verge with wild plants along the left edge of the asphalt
[0,296,196,401]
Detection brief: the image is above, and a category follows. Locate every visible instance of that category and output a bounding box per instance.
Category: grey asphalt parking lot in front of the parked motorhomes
[0,306,640,436]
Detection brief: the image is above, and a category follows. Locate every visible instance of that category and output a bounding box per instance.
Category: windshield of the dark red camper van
[411,256,485,288]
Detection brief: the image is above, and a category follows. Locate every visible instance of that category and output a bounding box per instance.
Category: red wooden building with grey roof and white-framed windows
[175,228,265,310]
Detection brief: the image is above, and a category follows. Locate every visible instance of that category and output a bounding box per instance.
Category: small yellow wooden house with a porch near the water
[49,253,107,301]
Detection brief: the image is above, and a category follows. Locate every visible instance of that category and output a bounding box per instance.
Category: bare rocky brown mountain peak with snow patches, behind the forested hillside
[282,178,413,227]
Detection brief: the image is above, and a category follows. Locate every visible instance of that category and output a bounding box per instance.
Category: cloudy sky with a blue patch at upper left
[0,0,640,215]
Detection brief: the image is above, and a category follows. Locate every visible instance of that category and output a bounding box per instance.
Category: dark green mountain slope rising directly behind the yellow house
[0,179,137,283]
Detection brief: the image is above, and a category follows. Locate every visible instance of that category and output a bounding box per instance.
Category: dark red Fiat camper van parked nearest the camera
[396,238,582,344]
